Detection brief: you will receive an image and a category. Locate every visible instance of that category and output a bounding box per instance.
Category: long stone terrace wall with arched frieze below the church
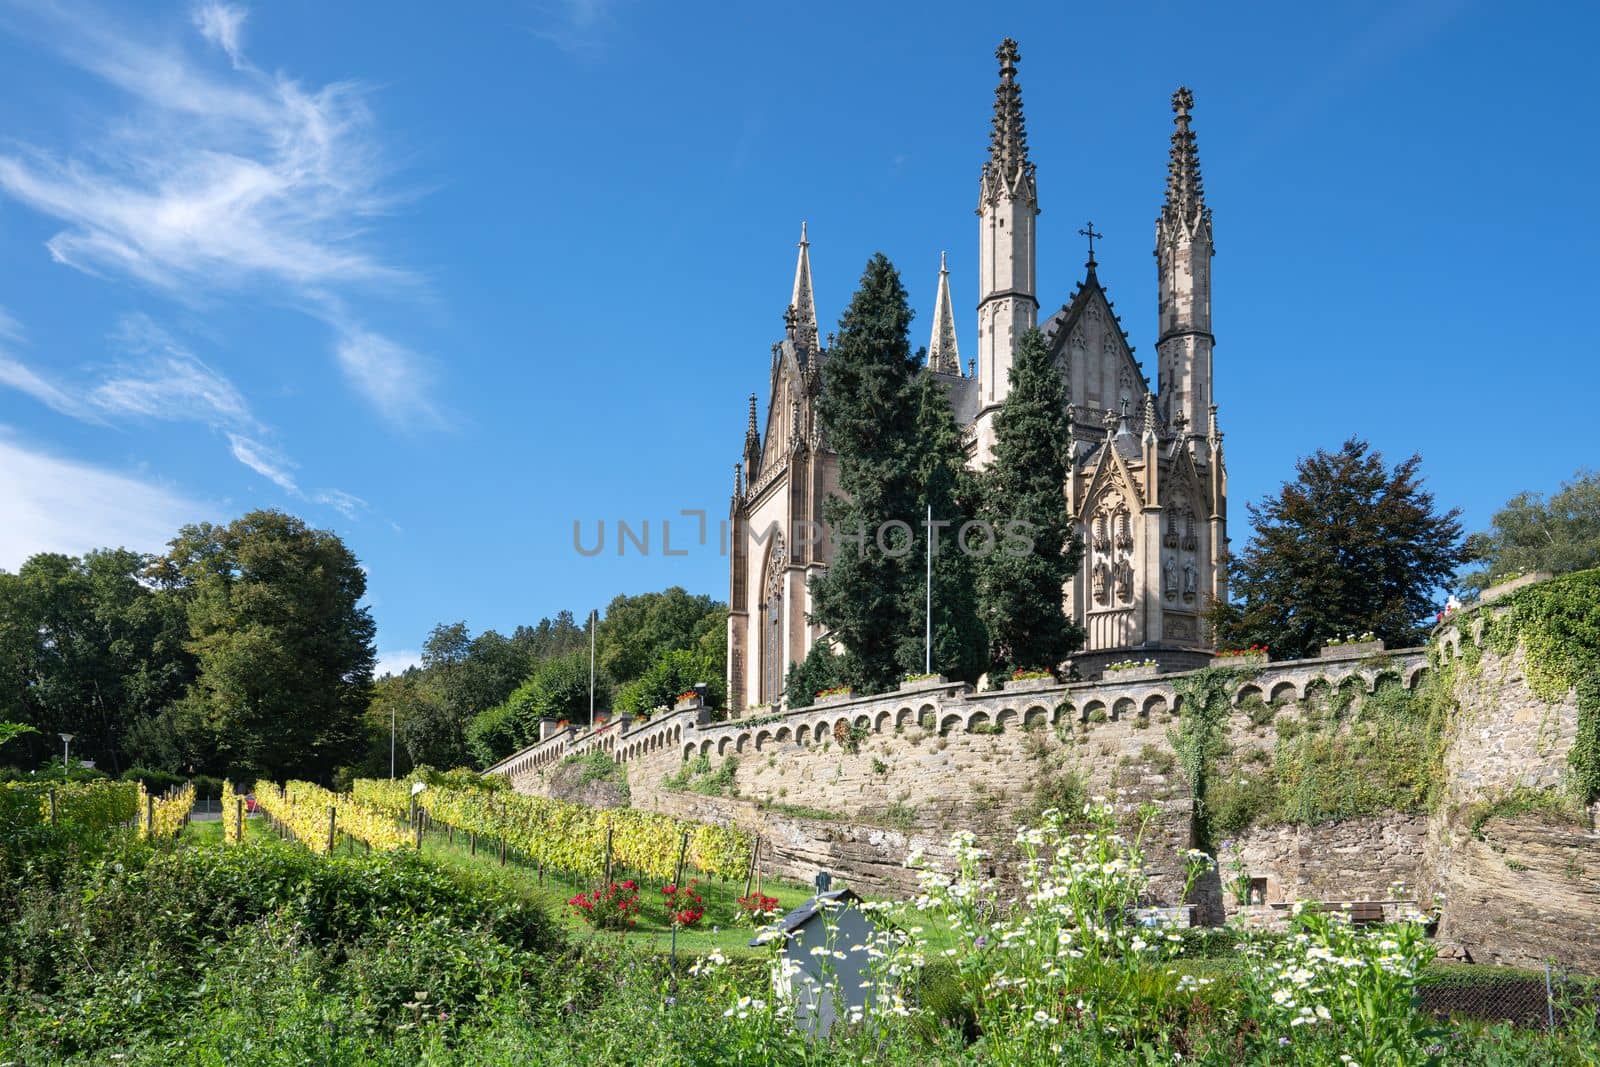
[496,649,1427,920]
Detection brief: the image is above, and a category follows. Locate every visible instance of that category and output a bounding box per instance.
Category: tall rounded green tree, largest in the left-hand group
[157,510,374,781]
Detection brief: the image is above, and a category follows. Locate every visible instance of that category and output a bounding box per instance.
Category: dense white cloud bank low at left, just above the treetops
[0,427,216,569]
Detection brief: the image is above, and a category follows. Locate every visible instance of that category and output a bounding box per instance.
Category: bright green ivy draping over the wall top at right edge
[1483,569,1600,803]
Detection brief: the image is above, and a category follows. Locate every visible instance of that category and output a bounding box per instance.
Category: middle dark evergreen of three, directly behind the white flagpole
[899,373,989,681]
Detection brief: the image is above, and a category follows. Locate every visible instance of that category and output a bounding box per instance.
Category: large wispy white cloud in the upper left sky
[0,3,406,293]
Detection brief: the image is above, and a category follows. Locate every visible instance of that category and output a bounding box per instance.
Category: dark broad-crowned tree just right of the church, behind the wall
[1208,437,1466,657]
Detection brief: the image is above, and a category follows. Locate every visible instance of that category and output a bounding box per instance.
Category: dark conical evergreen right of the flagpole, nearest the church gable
[978,330,1083,670]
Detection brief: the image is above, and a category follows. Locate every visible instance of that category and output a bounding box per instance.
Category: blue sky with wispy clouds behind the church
[0,0,1600,664]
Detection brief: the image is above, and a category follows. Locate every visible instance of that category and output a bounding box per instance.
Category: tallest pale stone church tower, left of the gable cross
[973,37,1038,467]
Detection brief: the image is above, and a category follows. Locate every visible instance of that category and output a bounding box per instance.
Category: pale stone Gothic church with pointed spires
[728,38,1227,709]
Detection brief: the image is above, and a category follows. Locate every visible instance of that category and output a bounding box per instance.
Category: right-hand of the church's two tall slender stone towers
[1155,88,1216,443]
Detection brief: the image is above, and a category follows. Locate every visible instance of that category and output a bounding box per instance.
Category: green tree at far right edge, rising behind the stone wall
[1461,470,1600,589]
